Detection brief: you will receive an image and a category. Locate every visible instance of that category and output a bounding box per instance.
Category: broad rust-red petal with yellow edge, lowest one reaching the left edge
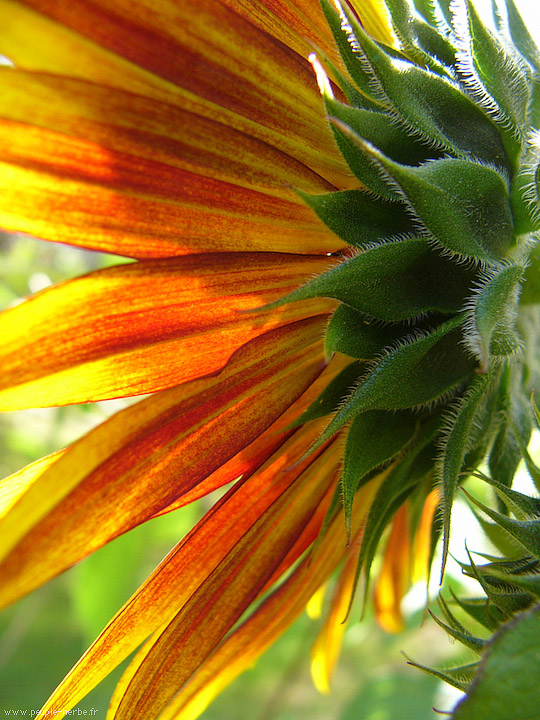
[0,318,322,604]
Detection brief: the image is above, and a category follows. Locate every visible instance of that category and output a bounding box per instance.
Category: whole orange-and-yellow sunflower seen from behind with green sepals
[0,0,539,720]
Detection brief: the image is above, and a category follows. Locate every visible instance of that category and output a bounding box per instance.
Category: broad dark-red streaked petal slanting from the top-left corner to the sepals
[9,0,354,186]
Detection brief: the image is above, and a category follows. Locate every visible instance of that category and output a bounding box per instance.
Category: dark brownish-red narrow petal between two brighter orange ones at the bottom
[109,448,339,720]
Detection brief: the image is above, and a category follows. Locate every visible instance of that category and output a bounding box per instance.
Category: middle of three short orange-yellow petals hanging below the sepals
[374,503,411,633]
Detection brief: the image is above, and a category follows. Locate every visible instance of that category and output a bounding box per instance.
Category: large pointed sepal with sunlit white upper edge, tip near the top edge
[345,3,508,169]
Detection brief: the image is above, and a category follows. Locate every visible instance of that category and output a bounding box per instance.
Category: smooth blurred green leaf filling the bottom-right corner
[452,606,540,720]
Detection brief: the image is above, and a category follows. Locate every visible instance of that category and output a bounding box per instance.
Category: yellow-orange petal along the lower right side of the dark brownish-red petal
[148,466,385,720]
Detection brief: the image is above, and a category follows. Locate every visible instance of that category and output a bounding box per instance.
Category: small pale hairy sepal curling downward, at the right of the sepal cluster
[465,264,524,372]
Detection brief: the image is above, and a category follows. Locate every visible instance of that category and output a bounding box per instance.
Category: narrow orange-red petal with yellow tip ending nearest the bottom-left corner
[39,414,330,709]
